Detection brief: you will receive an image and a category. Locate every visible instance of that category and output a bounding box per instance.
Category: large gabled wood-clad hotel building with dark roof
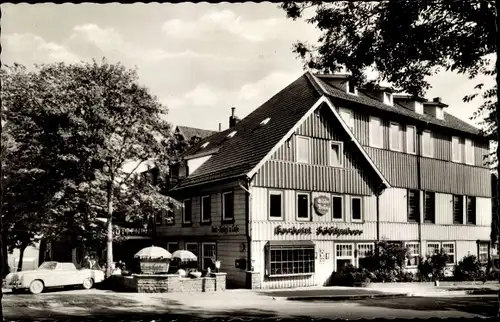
[158,73,492,288]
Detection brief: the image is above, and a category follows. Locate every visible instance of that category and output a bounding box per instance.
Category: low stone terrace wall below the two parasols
[133,273,226,293]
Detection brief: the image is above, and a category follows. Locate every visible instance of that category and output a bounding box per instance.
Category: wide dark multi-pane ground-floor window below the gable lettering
[268,246,315,276]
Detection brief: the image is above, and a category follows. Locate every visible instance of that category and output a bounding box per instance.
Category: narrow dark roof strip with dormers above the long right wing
[314,75,480,135]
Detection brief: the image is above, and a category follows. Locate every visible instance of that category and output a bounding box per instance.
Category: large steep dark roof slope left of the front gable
[174,75,321,190]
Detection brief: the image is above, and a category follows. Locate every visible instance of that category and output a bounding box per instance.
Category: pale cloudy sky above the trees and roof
[1,3,494,130]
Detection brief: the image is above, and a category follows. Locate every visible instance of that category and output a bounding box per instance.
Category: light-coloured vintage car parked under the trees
[5,262,104,294]
